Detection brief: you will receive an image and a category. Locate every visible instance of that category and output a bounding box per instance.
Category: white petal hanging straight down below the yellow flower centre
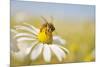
[43,44,51,62]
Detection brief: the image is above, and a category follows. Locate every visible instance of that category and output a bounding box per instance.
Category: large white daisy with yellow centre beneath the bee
[10,23,69,62]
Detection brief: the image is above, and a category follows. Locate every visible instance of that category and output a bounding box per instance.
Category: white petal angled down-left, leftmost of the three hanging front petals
[31,44,43,60]
